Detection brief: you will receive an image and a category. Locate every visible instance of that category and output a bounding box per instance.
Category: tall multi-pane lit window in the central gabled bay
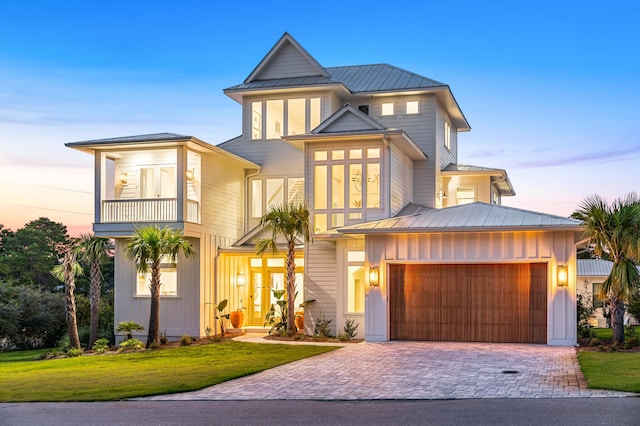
[312,147,381,232]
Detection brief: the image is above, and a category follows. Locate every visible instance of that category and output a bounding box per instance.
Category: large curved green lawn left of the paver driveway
[0,341,337,402]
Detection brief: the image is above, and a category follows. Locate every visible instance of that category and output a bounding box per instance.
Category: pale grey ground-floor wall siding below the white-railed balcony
[114,238,202,343]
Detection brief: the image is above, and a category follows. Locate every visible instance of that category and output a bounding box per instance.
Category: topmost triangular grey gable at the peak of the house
[244,32,329,84]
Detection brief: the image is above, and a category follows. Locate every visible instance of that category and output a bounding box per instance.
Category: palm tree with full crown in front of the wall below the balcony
[126,225,194,347]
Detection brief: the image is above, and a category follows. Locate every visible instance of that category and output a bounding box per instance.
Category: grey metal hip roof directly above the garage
[338,202,581,234]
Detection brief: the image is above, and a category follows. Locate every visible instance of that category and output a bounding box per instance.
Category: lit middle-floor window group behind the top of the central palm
[249,178,304,219]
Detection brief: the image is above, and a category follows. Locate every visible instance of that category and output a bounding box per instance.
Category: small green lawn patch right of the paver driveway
[578,351,640,393]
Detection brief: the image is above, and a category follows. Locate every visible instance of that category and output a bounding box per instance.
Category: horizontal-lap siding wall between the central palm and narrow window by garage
[304,239,338,335]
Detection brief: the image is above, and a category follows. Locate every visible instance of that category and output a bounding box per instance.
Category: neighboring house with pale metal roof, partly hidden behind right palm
[577,259,638,327]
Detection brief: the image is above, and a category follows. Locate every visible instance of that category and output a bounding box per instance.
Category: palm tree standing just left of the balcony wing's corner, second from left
[78,234,111,348]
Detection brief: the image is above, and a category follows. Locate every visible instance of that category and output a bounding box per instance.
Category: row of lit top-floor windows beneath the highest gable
[251,98,321,139]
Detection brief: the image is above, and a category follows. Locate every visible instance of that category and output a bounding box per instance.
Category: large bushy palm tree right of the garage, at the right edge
[572,193,640,344]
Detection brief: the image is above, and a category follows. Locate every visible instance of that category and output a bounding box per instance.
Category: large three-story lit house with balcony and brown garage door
[67,33,580,345]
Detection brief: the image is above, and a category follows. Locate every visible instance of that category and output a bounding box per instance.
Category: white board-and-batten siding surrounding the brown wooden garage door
[365,231,576,345]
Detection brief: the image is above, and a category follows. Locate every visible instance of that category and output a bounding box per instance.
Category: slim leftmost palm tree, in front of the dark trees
[51,244,82,349]
